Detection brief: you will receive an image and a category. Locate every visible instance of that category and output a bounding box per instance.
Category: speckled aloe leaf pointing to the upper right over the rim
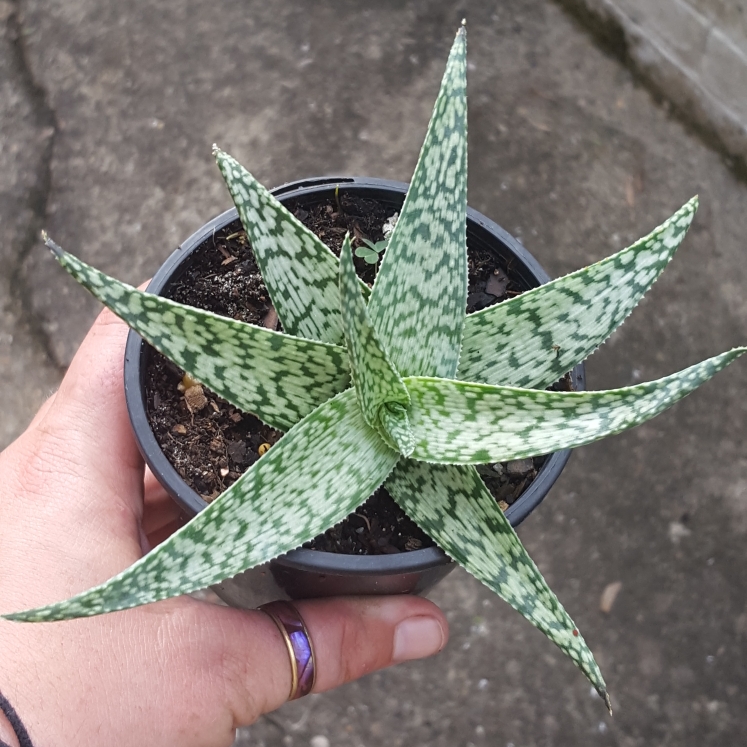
[456,197,698,389]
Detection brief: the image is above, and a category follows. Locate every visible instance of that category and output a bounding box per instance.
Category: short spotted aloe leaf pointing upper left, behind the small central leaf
[213,146,342,343]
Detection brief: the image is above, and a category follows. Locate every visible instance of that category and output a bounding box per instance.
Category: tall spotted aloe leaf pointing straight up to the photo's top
[368,28,467,378]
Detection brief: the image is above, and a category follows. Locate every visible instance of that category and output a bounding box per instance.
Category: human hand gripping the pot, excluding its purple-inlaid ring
[0,311,448,747]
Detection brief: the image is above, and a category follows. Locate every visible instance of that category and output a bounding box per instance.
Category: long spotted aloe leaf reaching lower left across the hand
[4,389,399,622]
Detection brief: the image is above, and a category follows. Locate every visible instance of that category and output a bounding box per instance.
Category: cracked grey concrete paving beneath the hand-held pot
[0,0,747,747]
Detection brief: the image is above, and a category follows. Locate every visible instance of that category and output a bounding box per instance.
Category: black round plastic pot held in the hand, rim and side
[124,177,585,607]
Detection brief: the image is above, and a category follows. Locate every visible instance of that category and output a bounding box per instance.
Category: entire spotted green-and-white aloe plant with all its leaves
[5,28,747,707]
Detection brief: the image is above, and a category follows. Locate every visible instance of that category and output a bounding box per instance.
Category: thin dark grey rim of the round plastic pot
[124,176,586,575]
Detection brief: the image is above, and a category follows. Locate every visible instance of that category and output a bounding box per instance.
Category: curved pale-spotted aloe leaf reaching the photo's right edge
[404,348,747,464]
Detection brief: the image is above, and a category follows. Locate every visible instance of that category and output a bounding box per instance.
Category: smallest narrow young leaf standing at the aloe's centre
[340,236,413,456]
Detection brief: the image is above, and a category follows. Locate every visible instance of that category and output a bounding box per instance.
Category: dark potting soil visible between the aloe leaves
[145,194,570,555]
